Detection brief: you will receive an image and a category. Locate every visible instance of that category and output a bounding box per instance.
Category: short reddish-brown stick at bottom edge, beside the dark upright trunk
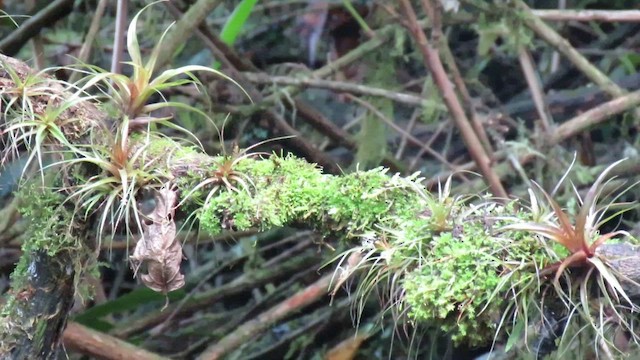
[63,322,168,360]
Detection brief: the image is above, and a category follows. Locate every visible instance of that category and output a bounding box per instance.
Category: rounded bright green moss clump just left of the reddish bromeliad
[398,202,549,346]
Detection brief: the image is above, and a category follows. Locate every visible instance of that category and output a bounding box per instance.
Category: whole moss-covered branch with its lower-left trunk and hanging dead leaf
[0,47,640,358]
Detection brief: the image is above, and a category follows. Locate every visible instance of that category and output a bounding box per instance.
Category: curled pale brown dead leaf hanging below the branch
[130,185,184,294]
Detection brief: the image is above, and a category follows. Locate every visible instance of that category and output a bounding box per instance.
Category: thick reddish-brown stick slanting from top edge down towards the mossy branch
[401,0,507,198]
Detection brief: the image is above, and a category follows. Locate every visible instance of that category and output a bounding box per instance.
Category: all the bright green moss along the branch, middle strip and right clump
[189,152,584,346]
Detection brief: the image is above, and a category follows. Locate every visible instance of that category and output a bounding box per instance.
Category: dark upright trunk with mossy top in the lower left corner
[0,187,91,359]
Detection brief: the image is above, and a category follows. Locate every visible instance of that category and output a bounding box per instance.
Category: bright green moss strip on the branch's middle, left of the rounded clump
[200,155,430,237]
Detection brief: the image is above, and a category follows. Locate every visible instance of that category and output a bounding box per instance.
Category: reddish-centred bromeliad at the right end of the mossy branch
[503,159,640,354]
